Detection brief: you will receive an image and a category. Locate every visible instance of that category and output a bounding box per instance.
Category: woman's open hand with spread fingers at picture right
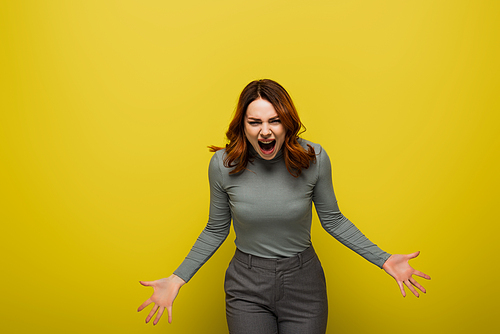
[382,252,431,297]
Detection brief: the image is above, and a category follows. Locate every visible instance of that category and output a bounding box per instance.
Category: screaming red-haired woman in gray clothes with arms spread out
[138,79,430,334]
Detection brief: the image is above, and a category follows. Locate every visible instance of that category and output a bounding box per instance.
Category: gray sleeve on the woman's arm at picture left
[174,153,231,282]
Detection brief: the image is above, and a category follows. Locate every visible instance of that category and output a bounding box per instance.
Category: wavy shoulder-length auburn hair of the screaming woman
[208,79,316,177]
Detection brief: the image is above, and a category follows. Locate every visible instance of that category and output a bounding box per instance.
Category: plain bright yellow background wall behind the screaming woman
[0,0,500,333]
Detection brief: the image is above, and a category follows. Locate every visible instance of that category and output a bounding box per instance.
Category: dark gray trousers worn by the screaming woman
[224,246,328,334]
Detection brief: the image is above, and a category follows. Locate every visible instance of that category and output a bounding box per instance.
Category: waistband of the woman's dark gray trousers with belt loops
[234,246,316,270]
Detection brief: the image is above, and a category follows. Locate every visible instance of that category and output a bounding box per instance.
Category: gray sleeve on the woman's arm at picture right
[313,147,391,268]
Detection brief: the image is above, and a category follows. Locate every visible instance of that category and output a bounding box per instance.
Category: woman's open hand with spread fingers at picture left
[137,275,186,325]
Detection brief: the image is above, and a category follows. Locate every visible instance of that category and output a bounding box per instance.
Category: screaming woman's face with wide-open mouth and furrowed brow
[245,99,286,160]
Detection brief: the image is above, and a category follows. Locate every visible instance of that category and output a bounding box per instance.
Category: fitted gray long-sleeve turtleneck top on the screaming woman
[174,139,390,282]
